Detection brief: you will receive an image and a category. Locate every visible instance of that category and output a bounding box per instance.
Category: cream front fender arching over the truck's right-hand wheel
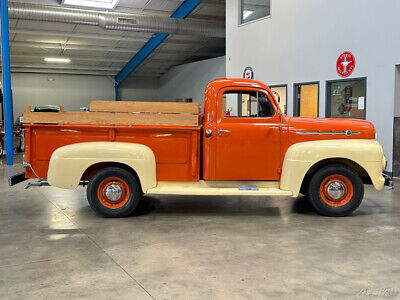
[280,139,385,197]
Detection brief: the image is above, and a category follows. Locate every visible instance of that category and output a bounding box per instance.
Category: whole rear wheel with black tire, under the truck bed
[87,167,142,218]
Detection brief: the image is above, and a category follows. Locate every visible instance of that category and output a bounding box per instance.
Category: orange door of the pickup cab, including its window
[215,87,281,180]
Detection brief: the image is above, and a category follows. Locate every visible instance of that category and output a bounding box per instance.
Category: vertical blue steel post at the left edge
[0,0,14,166]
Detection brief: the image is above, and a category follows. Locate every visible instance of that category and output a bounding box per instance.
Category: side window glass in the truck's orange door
[222,91,275,118]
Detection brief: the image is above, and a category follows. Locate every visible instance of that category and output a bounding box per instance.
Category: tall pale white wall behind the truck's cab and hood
[226,0,400,171]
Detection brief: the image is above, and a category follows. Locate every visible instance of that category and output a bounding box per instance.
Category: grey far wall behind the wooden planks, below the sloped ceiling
[3,57,225,118]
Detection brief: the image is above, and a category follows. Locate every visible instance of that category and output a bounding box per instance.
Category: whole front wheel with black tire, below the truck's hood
[308,164,364,217]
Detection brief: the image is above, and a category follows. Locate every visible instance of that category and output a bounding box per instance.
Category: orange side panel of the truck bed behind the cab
[25,124,200,181]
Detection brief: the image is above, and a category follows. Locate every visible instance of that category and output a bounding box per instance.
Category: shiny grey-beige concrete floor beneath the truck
[0,155,400,299]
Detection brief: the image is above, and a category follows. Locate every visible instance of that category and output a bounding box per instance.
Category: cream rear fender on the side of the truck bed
[47,142,156,192]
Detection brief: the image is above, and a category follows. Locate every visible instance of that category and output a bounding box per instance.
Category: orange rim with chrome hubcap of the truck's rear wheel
[97,177,130,209]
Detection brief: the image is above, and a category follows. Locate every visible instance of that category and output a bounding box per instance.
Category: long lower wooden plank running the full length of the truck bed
[24,106,199,126]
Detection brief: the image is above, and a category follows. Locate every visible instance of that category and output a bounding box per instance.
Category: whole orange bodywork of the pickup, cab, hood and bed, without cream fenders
[24,79,375,181]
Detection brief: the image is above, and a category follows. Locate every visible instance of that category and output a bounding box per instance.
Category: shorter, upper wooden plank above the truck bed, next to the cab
[89,101,201,115]
